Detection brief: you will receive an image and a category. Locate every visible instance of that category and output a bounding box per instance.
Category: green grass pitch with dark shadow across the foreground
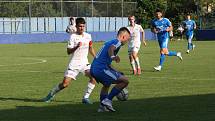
[0,41,215,121]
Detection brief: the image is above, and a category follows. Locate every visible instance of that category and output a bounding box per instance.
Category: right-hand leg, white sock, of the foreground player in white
[82,69,96,104]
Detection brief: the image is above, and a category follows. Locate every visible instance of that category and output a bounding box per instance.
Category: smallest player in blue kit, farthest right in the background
[182,14,196,53]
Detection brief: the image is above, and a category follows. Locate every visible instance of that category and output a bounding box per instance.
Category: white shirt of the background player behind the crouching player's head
[127,24,144,48]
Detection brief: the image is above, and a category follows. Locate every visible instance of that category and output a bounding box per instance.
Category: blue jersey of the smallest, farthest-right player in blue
[183,20,196,36]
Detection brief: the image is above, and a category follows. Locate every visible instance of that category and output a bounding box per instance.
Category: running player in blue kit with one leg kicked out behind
[151,9,182,71]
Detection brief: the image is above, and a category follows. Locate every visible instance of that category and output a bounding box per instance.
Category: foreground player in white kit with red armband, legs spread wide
[44,18,96,104]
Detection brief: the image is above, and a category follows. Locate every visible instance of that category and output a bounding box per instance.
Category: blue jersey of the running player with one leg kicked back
[151,18,172,41]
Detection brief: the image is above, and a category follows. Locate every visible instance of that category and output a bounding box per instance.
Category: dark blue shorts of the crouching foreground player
[90,68,123,86]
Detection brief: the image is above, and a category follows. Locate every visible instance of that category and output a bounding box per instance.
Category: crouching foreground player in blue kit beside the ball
[90,27,130,112]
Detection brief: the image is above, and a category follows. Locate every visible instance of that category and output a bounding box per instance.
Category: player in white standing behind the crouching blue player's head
[127,15,146,75]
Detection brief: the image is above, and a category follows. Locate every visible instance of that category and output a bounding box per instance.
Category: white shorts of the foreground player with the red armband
[64,64,90,80]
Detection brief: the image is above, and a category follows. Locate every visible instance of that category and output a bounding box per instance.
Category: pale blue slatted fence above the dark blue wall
[0,17,128,34]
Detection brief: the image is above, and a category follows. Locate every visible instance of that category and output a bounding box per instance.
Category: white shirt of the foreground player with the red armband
[67,32,92,69]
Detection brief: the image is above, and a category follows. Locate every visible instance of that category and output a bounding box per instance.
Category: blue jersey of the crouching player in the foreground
[91,39,122,69]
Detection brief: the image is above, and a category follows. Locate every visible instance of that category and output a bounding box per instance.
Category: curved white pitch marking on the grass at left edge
[0,58,47,67]
